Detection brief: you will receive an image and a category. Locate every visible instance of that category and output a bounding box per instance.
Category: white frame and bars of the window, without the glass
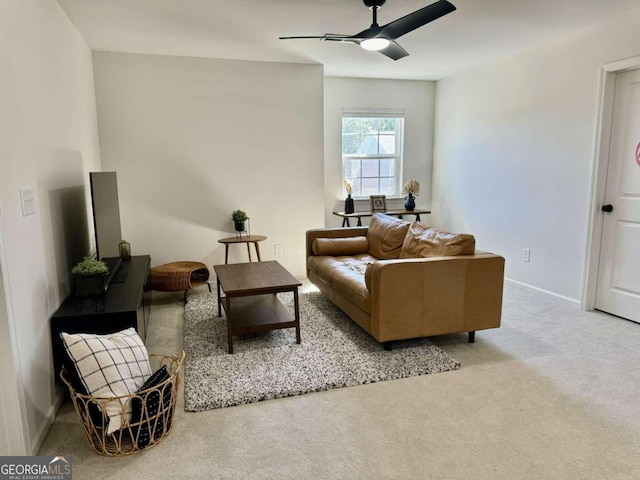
[340,108,404,199]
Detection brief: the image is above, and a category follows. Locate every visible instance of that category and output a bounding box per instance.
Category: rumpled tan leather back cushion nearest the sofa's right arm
[400,222,476,258]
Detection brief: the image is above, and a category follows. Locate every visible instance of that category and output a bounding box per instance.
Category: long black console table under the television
[51,255,151,380]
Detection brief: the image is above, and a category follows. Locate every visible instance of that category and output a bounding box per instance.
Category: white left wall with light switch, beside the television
[0,0,100,453]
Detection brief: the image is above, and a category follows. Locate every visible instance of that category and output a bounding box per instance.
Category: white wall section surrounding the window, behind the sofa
[324,77,436,226]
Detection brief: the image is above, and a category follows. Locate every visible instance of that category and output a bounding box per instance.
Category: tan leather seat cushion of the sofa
[307,254,377,314]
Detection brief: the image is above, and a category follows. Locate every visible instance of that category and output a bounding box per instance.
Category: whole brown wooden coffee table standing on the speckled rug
[213,261,302,353]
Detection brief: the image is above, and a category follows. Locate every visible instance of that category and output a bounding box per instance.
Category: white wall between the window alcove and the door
[433,15,640,300]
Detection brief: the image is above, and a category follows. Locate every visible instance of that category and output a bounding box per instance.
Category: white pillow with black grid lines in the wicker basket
[60,328,151,434]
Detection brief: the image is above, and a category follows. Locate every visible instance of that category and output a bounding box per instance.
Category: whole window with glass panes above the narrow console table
[342,109,404,197]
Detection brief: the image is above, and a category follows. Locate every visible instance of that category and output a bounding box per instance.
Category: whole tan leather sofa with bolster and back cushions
[306,214,504,348]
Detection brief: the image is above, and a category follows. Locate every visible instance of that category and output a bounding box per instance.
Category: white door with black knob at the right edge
[596,70,640,322]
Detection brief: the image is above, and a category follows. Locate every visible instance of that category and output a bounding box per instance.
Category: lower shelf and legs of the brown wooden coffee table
[222,291,300,353]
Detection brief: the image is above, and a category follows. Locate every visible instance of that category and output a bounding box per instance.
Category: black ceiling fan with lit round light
[279,0,456,60]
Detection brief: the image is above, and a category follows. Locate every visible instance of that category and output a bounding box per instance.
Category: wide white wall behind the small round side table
[94,52,323,277]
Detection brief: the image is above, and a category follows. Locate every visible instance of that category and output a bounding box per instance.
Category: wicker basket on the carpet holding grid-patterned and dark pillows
[60,328,185,456]
